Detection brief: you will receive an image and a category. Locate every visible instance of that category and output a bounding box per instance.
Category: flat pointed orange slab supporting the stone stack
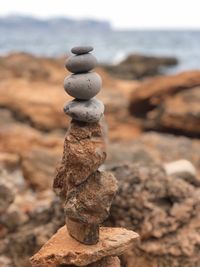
[30,226,139,267]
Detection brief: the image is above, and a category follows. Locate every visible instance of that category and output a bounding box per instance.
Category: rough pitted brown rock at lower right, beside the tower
[108,161,200,267]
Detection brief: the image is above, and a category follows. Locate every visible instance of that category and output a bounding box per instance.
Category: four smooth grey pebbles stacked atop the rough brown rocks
[64,46,104,122]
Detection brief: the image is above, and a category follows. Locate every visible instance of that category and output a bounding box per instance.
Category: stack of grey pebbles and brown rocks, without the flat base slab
[54,46,117,245]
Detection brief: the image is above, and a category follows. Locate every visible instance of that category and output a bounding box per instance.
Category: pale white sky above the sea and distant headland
[0,0,200,29]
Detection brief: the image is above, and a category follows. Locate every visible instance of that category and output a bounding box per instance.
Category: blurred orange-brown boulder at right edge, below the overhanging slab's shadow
[146,86,200,137]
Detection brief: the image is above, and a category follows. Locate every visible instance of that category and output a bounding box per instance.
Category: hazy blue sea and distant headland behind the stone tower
[0,15,200,73]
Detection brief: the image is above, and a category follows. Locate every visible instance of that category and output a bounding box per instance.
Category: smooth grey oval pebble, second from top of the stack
[65,53,97,73]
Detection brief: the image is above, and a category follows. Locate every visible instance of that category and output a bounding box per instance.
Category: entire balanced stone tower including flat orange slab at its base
[31,46,138,267]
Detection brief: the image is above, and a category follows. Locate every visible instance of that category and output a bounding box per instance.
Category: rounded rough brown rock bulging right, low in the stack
[64,171,117,224]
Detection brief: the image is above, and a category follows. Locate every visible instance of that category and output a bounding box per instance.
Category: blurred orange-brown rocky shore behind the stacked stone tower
[0,54,200,267]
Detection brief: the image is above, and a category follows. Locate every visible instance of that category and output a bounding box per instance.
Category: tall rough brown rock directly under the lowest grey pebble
[54,120,106,199]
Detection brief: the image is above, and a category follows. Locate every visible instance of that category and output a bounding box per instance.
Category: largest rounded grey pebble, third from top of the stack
[64,72,102,100]
